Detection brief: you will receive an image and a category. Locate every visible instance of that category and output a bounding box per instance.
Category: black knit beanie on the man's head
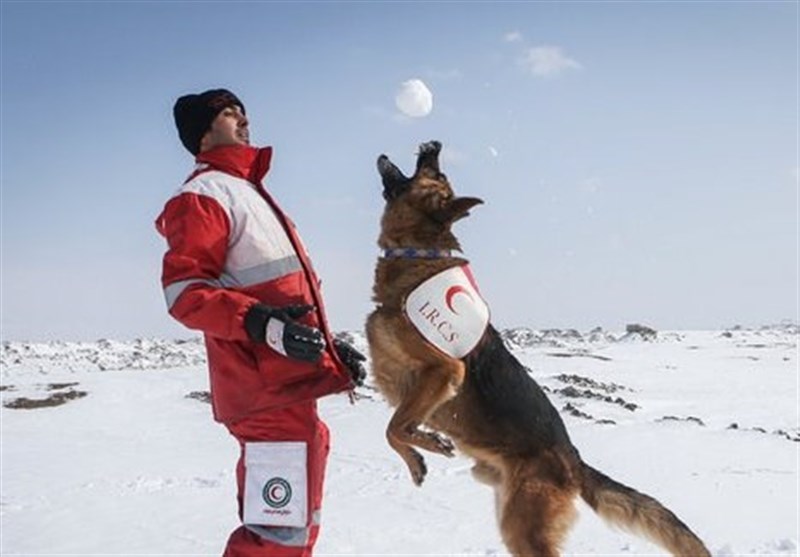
[172,89,244,155]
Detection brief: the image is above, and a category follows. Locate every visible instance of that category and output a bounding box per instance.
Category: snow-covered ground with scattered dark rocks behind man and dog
[0,325,800,556]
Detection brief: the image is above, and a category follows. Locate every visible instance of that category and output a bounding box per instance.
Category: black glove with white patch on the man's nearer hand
[244,304,325,362]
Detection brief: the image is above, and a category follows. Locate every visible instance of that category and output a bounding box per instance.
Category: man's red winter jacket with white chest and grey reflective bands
[156,145,352,423]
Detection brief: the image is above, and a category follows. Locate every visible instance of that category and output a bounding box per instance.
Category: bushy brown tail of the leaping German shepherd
[581,463,711,557]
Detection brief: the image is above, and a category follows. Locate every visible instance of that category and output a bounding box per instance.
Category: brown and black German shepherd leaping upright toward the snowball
[366,141,710,557]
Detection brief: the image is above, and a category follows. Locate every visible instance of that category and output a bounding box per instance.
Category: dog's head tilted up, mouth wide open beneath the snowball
[378,141,483,249]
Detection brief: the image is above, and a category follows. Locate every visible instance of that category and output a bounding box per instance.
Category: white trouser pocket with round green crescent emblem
[243,441,308,528]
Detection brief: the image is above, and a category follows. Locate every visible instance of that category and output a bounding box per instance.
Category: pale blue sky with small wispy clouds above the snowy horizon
[0,0,798,340]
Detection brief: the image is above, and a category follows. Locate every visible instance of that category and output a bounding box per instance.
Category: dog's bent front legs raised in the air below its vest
[386,360,464,485]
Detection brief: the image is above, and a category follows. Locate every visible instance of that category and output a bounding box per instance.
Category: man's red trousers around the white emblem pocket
[223,401,330,557]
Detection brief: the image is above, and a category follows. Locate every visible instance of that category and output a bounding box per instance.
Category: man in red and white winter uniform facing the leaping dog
[156,89,365,557]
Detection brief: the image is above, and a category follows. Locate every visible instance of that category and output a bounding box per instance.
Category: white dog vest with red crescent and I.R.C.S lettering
[404,265,489,358]
